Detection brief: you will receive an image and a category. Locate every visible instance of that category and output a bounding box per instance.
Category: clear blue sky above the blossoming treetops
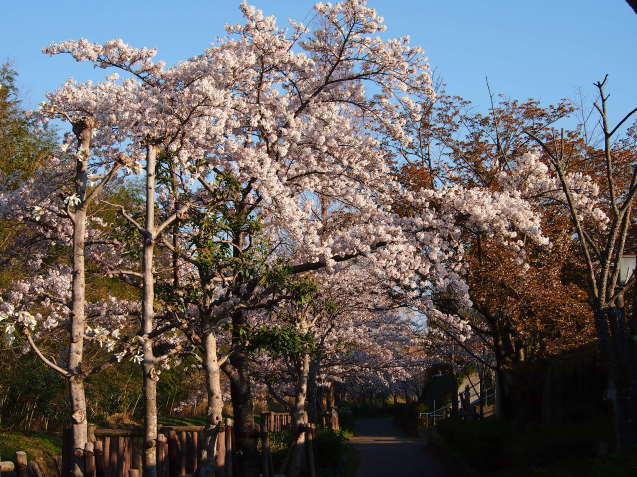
[0,0,637,124]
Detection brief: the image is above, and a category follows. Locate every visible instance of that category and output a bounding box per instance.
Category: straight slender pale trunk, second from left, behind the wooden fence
[142,144,159,477]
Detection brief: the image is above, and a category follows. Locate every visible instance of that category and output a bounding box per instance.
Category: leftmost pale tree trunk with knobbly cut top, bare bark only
[68,118,95,477]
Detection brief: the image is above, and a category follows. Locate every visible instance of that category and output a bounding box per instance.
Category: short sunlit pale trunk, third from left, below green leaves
[199,331,225,477]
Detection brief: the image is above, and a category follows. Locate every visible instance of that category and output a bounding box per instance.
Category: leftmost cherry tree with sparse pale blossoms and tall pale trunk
[3,69,138,475]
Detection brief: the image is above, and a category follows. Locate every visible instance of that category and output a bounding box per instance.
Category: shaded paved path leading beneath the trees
[350,417,445,477]
